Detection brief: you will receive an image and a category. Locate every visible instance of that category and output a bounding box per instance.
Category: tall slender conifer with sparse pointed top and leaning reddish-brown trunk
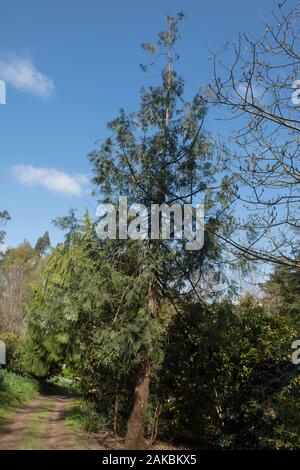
[90,13,231,449]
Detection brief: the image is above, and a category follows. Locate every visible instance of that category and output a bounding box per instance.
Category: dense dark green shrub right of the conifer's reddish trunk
[159,302,300,449]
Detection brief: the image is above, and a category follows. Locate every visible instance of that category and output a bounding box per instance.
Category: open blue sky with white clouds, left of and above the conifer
[0,0,275,250]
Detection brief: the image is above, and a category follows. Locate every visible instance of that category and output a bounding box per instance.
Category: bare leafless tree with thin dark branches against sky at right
[209,1,300,268]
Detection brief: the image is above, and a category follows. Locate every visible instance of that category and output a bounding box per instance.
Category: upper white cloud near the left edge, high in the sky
[0,54,54,98]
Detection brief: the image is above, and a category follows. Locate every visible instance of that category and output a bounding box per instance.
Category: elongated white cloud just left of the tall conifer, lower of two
[12,165,89,196]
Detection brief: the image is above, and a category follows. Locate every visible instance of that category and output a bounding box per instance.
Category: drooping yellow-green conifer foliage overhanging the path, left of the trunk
[28,214,162,382]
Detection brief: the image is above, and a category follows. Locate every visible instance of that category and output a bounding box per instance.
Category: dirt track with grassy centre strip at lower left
[0,395,74,450]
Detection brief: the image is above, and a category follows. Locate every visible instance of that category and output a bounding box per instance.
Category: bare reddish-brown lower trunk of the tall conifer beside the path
[125,360,151,450]
